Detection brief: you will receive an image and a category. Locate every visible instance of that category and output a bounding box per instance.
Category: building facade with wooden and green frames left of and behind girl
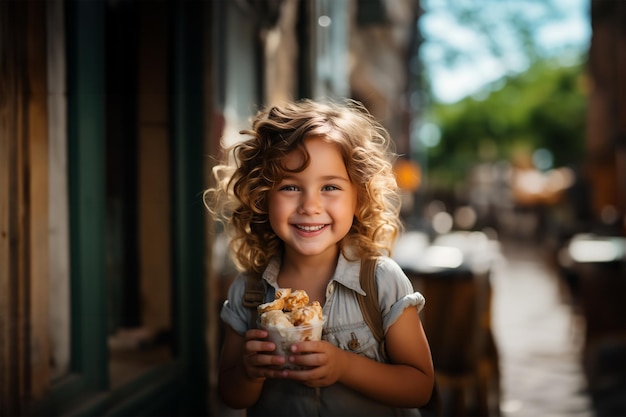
[0,0,419,416]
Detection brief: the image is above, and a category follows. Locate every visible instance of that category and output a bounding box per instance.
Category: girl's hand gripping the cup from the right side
[285,340,348,387]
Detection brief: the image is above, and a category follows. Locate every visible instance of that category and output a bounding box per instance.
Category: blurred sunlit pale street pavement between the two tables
[492,237,594,417]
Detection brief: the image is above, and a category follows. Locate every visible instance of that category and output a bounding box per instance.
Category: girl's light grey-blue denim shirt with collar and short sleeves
[221,255,425,417]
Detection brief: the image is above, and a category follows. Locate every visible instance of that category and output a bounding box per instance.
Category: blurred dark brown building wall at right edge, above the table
[585,1,626,236]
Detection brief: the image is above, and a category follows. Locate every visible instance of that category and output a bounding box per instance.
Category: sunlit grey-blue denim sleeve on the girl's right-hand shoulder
[376,257,426,333]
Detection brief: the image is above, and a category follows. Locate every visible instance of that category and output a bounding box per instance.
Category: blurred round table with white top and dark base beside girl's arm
[394,232,500,417]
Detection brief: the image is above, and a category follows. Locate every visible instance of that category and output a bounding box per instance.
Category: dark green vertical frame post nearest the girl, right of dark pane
[171,1,208,415]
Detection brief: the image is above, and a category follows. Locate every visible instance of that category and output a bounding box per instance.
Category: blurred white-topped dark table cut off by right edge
[559,234,626,416]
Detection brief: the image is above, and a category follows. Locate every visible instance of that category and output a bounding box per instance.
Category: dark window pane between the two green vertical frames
[106,2,172,388]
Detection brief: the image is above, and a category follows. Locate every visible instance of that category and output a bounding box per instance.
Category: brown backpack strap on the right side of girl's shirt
[357,258,387,359]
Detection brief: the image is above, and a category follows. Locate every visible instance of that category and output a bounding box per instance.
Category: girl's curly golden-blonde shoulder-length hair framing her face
[204,100,402,273]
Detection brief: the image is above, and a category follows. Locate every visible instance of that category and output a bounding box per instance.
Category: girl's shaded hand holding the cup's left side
[243,329,285,380]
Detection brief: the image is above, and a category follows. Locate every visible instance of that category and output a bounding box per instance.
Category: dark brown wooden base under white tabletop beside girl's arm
[405,267,500,417]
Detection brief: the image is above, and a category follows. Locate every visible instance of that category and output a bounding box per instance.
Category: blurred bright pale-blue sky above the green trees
[420,0,591,103]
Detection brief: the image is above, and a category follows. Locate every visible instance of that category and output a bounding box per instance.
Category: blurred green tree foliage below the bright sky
[425,59,586,189]
